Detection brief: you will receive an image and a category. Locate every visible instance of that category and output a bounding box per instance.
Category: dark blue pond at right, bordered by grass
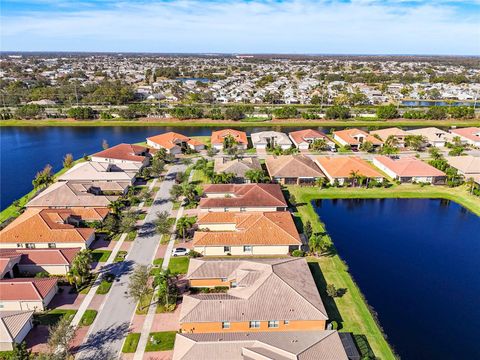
[313,199,480,359]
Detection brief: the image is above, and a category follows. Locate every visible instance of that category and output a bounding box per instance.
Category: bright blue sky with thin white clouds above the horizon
[0,0,480,55]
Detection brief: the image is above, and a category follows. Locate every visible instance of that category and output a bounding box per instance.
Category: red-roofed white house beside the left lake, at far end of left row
[91,144,151,168]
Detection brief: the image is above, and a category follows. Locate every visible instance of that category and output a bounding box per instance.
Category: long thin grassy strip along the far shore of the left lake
[0,119,480,127]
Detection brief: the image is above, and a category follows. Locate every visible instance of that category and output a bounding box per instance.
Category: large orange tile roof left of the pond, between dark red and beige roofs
[193,211,301,246]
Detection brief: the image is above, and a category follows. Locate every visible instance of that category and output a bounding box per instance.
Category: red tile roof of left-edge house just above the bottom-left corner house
[0,278,57,301]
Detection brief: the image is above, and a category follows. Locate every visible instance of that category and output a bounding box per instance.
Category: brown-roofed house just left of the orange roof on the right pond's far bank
[265,155,325,185]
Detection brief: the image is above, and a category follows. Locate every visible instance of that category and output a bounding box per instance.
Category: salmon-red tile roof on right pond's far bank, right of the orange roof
[375,156,445,176]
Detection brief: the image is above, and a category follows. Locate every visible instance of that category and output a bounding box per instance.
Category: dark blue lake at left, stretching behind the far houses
[0,126,342,210]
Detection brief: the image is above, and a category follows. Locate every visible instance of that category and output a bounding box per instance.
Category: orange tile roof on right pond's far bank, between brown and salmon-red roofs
[315,156,383,178]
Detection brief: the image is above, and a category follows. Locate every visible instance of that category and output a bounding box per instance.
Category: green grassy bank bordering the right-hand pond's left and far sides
[288,185,480,359]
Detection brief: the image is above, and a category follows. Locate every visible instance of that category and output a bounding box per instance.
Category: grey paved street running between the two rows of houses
[77,165,186,359]
